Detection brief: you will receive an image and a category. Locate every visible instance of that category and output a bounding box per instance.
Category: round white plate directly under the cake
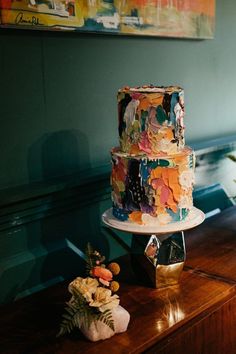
[102,207,205,235]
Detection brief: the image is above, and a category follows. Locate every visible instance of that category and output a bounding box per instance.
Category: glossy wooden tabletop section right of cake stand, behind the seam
[185,207,236,282]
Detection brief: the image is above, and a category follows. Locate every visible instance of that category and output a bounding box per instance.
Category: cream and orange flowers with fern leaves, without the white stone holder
[57,244,120,336]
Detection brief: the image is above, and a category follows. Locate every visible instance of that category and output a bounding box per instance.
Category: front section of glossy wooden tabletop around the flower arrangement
[0,272,233,353]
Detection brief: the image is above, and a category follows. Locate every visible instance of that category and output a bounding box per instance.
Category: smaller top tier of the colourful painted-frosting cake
[117,85,184,156]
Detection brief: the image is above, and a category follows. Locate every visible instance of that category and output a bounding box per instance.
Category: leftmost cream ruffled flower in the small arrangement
[68,277,99,302]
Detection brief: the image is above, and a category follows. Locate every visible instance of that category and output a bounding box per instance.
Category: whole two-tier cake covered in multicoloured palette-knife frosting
[111,86,195,226]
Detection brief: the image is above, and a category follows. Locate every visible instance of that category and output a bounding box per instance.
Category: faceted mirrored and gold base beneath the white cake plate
[131,232,186,288]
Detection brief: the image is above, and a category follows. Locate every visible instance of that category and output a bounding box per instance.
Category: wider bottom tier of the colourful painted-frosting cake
[111,147,195,226]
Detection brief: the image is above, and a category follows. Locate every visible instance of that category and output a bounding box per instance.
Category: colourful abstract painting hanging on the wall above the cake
[0,0,215,38]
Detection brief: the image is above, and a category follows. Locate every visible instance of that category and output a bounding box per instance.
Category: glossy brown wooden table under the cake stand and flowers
[0,207,236,354]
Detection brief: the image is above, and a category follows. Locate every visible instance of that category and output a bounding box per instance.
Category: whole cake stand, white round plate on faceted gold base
[102,207,205,288]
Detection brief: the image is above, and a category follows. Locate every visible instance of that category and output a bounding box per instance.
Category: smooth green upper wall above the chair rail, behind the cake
[0,0,236,189]
